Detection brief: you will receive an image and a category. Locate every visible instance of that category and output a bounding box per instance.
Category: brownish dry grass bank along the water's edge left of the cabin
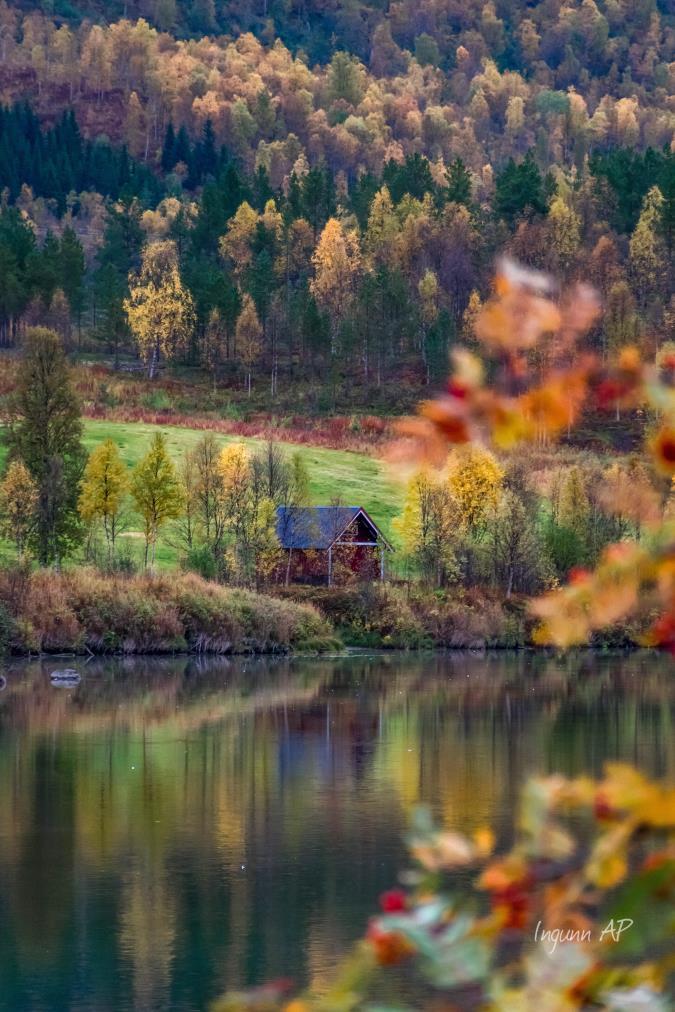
[0,568,336,654]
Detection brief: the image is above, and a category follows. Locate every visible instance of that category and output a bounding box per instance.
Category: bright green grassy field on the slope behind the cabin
[0,421,403,565]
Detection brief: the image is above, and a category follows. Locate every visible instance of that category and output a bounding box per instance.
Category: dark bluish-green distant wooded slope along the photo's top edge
[6,0,674,76]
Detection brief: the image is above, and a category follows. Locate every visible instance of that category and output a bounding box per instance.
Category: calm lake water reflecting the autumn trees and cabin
[0,655,675,1012]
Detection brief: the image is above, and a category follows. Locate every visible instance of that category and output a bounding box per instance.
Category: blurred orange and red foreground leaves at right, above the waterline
[392,259,675,652]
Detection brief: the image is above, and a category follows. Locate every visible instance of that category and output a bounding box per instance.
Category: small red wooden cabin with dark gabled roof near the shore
[276,506,393,587]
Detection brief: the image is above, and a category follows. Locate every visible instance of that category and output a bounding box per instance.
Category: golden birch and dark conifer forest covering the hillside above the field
[0,0,675,411]
